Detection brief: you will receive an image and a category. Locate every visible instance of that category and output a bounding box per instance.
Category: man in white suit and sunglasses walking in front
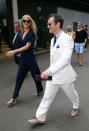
[28,14,79,124]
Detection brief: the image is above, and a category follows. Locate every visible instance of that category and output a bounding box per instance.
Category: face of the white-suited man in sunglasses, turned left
[47,17,59,34]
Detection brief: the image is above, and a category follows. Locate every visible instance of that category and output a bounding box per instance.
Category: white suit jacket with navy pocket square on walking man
[49,32,77,84]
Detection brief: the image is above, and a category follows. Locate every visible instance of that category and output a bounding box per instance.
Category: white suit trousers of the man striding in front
[36,81,79,121]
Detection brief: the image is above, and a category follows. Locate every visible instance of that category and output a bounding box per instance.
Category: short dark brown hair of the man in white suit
[48,13,64,28]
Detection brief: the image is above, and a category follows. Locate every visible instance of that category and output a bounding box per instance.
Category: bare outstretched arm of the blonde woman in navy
[6,42,31,57]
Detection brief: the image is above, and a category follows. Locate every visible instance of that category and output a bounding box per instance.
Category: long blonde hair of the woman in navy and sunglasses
[21,14,37,33]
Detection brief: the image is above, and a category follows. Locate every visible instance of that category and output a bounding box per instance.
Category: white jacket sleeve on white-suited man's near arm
[49,37,74,75]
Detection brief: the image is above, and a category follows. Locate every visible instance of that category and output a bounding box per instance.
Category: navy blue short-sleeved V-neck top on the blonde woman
[21,30,36,57]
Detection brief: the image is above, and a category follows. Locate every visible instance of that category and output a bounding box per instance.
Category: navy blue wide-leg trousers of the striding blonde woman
[12,56,43,98]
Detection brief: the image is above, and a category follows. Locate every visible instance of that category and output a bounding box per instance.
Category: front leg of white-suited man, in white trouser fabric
[36,81,60,121]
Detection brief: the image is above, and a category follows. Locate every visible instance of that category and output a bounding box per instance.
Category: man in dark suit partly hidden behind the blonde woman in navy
[12,22,22,64]
